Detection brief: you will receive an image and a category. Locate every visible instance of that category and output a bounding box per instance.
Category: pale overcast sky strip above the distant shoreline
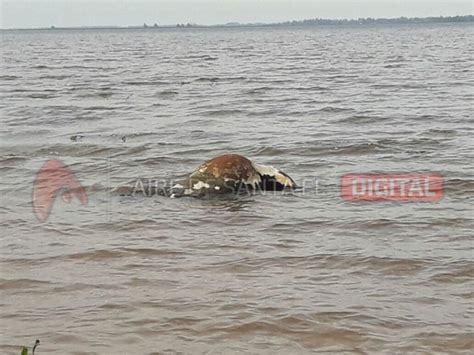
[0,0,474,28]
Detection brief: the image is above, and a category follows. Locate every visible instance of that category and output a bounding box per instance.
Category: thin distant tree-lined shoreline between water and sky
[0,15,474,31]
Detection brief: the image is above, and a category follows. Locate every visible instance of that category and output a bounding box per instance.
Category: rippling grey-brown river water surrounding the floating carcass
[0,24,474,354]
